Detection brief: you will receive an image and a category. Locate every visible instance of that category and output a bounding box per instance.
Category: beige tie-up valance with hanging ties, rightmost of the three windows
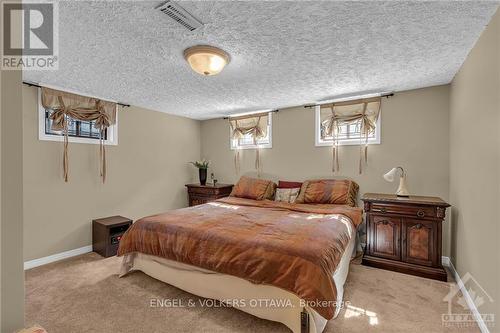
[320,97,382,174]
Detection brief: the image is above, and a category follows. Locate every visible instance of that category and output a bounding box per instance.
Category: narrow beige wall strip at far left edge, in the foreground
[0,57,24,333]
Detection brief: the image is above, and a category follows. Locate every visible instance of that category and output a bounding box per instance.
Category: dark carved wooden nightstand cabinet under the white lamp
[361,193,450,281]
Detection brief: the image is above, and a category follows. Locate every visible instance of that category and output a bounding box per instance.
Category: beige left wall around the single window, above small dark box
[23,87,200,260]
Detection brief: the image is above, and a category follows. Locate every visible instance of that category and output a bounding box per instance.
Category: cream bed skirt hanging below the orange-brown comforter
[120,231,355,333]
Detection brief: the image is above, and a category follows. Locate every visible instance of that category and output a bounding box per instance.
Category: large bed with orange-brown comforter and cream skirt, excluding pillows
[118,183,362,333]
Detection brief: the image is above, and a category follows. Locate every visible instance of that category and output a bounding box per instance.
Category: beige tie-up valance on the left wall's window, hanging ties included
[41,87,116,182]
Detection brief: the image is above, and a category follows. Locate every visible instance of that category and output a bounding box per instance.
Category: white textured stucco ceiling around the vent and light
[24,1,498,119]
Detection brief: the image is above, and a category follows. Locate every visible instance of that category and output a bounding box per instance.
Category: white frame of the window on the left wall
[37,89,118,146]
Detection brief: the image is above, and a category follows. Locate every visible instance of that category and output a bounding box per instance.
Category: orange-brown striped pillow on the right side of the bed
[295,179,359,207]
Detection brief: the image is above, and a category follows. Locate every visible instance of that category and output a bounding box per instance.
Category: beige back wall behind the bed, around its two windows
[201,86,449,255]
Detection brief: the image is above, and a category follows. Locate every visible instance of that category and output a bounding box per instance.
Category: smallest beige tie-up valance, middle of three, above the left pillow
[229,112,269,175]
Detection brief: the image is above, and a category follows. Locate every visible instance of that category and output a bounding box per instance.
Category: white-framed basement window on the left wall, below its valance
[38,89,118,145]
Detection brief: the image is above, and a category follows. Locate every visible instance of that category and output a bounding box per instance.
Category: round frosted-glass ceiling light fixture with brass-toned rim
[184,45,229,76]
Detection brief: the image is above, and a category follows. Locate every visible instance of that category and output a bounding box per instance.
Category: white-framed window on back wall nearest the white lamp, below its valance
[315,107,381,147]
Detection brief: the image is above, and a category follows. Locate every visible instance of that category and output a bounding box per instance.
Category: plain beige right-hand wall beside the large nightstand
[450,8,500,322]
